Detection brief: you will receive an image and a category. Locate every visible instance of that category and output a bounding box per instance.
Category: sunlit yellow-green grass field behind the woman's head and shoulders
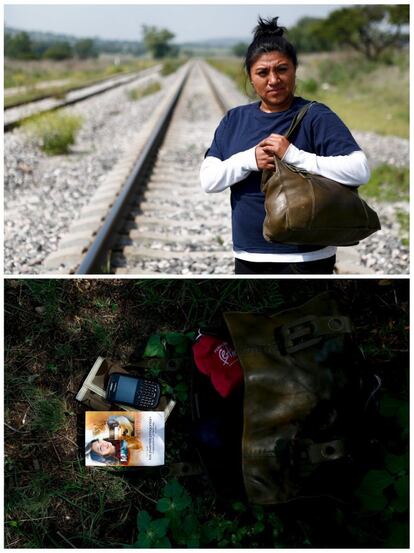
[208,52,409,138]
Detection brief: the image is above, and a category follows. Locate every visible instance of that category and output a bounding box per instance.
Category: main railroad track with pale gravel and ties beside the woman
[45,62,240,275]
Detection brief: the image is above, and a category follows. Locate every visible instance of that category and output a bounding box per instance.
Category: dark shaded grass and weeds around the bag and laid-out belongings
[4,279,409,549]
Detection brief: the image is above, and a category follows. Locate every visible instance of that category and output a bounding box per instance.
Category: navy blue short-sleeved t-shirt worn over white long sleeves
[206,97,360,253]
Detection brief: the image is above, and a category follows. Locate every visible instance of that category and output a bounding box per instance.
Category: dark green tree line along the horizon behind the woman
[4,4,409,60]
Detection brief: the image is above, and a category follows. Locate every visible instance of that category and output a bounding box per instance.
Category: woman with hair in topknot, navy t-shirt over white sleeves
[200,17,370,274]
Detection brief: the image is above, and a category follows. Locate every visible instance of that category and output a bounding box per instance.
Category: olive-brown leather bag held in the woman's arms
[261,102,381,246]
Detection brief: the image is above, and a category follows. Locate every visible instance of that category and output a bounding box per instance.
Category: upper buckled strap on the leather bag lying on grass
[276,315,352,353]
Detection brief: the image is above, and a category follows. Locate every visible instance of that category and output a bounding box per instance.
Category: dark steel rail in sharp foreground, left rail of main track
[76,66,192,275]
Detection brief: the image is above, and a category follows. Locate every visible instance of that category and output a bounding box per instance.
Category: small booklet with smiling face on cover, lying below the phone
[85,411,165,467]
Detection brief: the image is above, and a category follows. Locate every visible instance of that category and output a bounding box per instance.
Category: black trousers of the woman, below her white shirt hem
[235,255,336,275]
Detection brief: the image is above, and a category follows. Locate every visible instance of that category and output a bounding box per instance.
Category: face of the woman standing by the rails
[250,52,296,112]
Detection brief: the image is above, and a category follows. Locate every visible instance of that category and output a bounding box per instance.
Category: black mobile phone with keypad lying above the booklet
[106,373,161,410]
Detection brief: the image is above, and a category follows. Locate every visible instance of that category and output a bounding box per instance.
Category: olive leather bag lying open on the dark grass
[224,293,374,504]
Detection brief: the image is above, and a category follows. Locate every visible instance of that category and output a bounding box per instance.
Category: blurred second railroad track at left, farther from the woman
[4,65,162,132]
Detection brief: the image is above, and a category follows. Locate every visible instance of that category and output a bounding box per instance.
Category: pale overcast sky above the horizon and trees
[4,3,341,42]
